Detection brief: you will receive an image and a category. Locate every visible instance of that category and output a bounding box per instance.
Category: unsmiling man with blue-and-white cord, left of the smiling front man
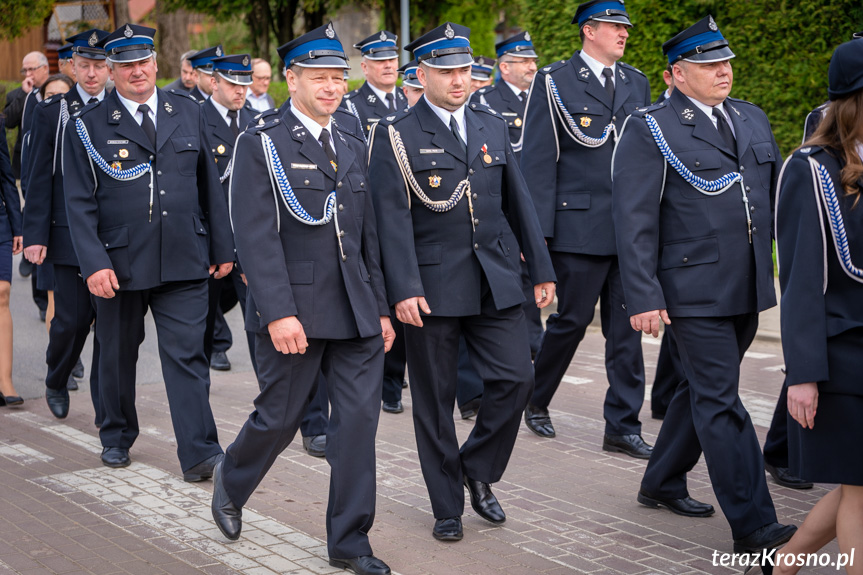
[63,24,234,481]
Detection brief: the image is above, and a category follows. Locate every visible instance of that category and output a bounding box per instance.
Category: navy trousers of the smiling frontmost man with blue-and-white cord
[222,333,384,559]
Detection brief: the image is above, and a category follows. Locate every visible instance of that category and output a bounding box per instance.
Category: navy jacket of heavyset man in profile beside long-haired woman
[613,90,782,317]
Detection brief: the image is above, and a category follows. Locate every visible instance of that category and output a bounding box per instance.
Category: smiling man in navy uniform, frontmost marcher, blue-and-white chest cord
[212,23,393,575]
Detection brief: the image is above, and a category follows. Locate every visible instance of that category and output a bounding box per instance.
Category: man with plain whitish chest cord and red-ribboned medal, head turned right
[369,23,554,541]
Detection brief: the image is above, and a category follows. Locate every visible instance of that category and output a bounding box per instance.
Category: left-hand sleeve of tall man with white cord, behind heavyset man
[521,74,560,238]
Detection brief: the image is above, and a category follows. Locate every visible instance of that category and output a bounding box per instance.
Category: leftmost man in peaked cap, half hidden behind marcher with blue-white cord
[24,29,108,425]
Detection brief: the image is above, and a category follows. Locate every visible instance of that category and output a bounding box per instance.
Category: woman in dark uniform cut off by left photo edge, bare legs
[0,106,24,407]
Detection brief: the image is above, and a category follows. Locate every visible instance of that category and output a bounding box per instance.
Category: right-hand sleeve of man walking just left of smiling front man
[198,111,235,265]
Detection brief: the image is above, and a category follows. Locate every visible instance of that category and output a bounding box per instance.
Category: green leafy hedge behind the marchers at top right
[520,0,863,155]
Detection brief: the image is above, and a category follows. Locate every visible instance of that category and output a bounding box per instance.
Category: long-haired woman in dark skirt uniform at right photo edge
[756,40,863,575]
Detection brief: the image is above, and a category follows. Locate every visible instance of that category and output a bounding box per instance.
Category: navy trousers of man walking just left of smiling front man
[94,280,222,471]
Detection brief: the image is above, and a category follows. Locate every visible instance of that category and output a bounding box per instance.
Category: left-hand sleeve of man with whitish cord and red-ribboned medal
[369,123,425,305]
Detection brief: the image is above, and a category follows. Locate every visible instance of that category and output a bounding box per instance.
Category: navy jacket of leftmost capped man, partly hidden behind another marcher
[24,87,90,266]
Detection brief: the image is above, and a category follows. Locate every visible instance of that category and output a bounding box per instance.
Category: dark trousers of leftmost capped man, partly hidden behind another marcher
[45,264,102,424]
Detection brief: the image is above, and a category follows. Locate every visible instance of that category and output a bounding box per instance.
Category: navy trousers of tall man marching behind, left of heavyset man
[530,251,644,435]
